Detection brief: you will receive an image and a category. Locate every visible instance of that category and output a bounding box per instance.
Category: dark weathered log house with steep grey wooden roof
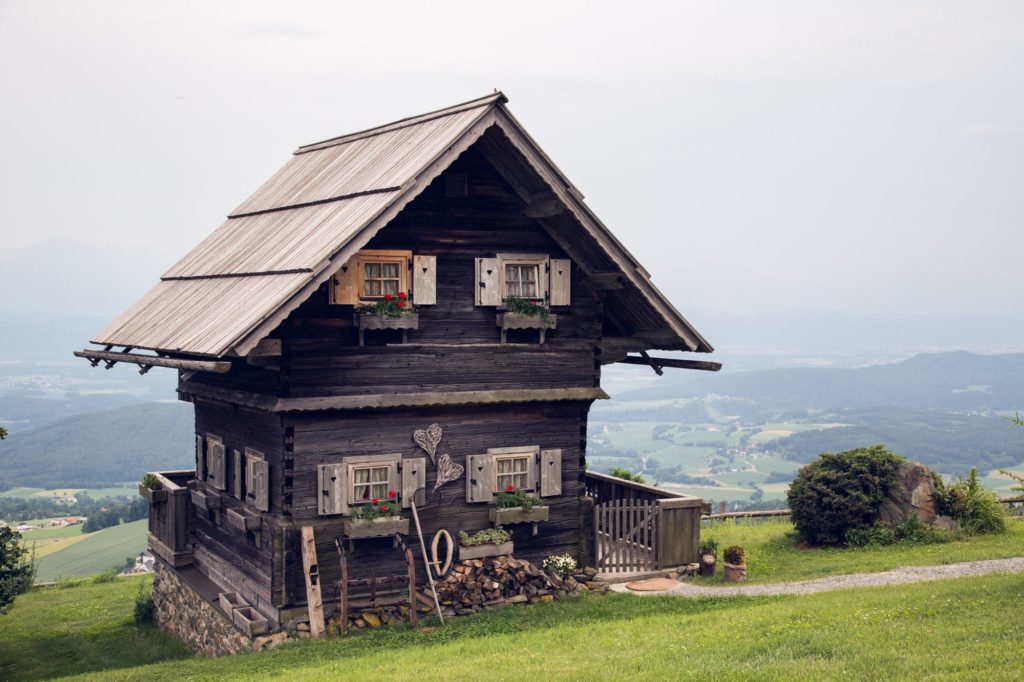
[76,93,716,643]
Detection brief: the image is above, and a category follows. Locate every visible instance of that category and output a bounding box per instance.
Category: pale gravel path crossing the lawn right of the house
[611,557,1024,597]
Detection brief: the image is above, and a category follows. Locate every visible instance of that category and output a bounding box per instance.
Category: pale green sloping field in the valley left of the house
[36,518,148,583]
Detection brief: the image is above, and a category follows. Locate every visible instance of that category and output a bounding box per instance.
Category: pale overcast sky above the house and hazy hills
[0,0,1024,314]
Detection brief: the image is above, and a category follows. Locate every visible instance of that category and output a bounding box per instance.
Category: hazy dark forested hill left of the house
[0,402,195,487]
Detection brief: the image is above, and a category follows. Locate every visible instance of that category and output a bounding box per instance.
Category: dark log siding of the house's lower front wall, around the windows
[284,402,589,605]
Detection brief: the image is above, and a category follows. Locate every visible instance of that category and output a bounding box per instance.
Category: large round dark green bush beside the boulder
[788,445,904,545]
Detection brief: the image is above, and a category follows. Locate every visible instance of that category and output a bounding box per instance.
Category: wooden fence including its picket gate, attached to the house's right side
[584,471,707,571]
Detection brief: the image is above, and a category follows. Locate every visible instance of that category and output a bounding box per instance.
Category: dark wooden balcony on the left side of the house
[150,470,196,567]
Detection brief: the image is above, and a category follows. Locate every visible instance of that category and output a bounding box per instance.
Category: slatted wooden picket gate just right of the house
[594,500,658,573]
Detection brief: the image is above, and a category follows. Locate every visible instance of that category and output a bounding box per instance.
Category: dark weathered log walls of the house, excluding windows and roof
[184,140,603,607]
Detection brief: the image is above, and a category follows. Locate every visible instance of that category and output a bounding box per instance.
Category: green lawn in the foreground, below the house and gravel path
[0,576,1024,680]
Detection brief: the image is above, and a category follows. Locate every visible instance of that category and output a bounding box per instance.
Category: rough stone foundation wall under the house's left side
[153,561,253,656]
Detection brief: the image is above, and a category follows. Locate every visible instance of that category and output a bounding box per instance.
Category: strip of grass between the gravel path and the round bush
[698,518,1024,585]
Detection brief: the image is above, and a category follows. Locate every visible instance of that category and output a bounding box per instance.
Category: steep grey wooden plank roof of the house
[92,92,711,356]
